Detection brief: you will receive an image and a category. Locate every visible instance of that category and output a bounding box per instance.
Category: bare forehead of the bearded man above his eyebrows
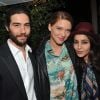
[10,13,29,22]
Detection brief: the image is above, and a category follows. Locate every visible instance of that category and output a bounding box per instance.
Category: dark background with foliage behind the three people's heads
[0,0,100,47]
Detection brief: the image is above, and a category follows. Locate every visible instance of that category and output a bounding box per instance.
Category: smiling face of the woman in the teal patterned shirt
[48,19,72,46]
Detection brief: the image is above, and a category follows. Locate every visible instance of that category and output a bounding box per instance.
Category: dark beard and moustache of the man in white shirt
[10,33,29,47]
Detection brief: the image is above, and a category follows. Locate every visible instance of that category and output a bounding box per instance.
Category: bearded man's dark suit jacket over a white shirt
[0,43,42,100]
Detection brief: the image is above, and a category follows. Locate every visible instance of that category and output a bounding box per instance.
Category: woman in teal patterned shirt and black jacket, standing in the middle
[36,11,78,100]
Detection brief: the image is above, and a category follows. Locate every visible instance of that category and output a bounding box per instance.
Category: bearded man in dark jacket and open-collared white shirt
[0,6,39,100]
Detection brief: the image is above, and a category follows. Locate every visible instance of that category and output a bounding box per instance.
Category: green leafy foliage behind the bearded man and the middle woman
[0,0,66,47]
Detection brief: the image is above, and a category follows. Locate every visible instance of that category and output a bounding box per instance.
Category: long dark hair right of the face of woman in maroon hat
[87,35,100,70]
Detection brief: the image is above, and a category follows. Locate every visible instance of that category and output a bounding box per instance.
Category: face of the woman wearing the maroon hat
[74,34,90,61]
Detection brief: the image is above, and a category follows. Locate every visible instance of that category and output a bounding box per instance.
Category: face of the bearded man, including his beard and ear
[6,13,30,46]
